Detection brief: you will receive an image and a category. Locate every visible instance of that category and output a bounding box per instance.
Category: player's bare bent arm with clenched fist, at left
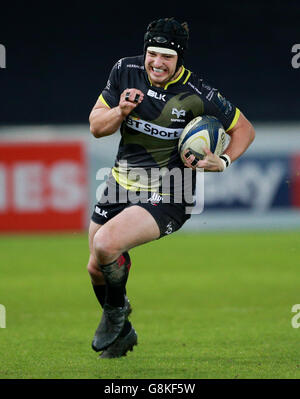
[89,89,144,138]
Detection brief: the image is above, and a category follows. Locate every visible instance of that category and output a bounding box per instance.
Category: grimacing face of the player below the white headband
[145,51,178,87]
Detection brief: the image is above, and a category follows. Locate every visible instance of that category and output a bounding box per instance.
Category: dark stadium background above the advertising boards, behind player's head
[0,1,300,125]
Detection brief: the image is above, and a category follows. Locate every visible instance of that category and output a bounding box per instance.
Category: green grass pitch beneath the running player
[0,232,300,379]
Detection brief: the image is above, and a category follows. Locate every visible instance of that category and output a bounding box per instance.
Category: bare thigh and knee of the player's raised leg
[93,205,160,264]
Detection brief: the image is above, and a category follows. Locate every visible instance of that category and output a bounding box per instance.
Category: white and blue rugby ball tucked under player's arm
[178,115,226,162]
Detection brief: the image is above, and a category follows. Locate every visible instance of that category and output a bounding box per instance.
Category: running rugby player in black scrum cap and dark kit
[88,18,255,358]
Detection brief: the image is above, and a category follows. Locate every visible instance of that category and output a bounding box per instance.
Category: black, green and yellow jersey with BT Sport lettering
[99,55,240,192]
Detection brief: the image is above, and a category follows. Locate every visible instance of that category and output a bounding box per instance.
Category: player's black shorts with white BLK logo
[91,177,191,238]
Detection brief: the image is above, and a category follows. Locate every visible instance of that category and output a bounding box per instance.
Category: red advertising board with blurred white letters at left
[0,141,88,232]
